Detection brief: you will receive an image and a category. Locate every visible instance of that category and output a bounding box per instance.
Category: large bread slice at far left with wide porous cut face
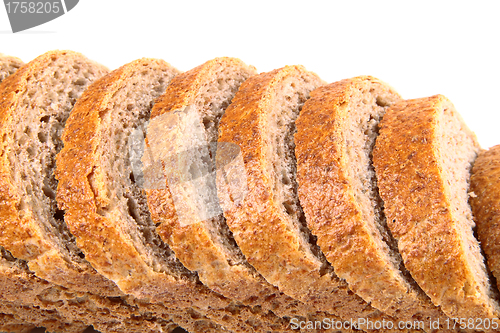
[0,51,118,295]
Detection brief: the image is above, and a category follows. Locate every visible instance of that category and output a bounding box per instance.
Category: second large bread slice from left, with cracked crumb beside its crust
[56,59,187,298]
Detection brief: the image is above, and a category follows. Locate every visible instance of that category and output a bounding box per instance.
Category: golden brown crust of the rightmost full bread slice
[373,95,497,319]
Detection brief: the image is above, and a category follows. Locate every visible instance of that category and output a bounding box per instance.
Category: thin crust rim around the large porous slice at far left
[0,51,117,295]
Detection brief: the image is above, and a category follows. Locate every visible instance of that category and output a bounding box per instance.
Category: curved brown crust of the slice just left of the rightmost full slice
[295,76,454,330]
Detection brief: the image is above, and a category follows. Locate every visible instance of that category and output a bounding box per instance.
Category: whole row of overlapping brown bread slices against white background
[0,51,500,333]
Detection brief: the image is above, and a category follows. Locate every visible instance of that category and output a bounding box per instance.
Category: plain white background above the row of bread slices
[0,0,500,148]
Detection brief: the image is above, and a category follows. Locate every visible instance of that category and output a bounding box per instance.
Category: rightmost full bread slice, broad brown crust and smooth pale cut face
[373,95,500,324]
